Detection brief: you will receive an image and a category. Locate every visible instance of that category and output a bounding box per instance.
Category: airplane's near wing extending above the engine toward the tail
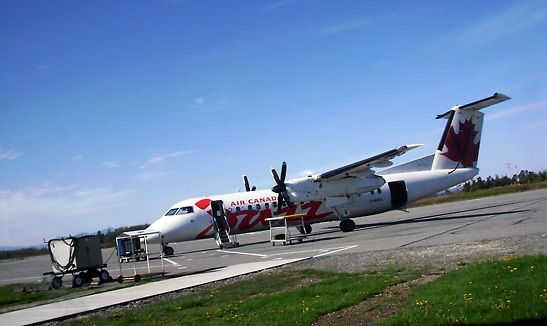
[317,144,423,180]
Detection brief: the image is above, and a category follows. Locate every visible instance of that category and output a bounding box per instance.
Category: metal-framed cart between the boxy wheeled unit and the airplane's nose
[116,230,165,283]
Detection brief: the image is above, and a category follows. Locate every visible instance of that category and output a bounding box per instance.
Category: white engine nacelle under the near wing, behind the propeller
[286,176,386,202]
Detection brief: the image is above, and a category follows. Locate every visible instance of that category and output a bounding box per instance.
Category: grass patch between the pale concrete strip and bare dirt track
[57,270,408,325]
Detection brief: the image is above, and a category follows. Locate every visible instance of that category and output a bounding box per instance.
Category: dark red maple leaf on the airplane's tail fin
[441,119,480,168]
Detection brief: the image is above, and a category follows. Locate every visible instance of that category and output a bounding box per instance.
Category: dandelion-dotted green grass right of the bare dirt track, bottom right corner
[377,255,547,325]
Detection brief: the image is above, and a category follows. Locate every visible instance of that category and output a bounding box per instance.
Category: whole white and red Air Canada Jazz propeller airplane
[146,93,510,256]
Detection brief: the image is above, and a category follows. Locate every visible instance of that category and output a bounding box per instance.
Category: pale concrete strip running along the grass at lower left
[0,258,306,326]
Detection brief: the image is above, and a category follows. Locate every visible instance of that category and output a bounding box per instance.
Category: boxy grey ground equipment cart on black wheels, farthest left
[44,235,110,289]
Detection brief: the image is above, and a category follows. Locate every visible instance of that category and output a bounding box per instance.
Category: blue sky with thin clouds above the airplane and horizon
[0,0,547,246]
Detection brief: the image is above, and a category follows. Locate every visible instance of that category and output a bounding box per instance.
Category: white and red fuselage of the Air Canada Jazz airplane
[149,168,478,244]
